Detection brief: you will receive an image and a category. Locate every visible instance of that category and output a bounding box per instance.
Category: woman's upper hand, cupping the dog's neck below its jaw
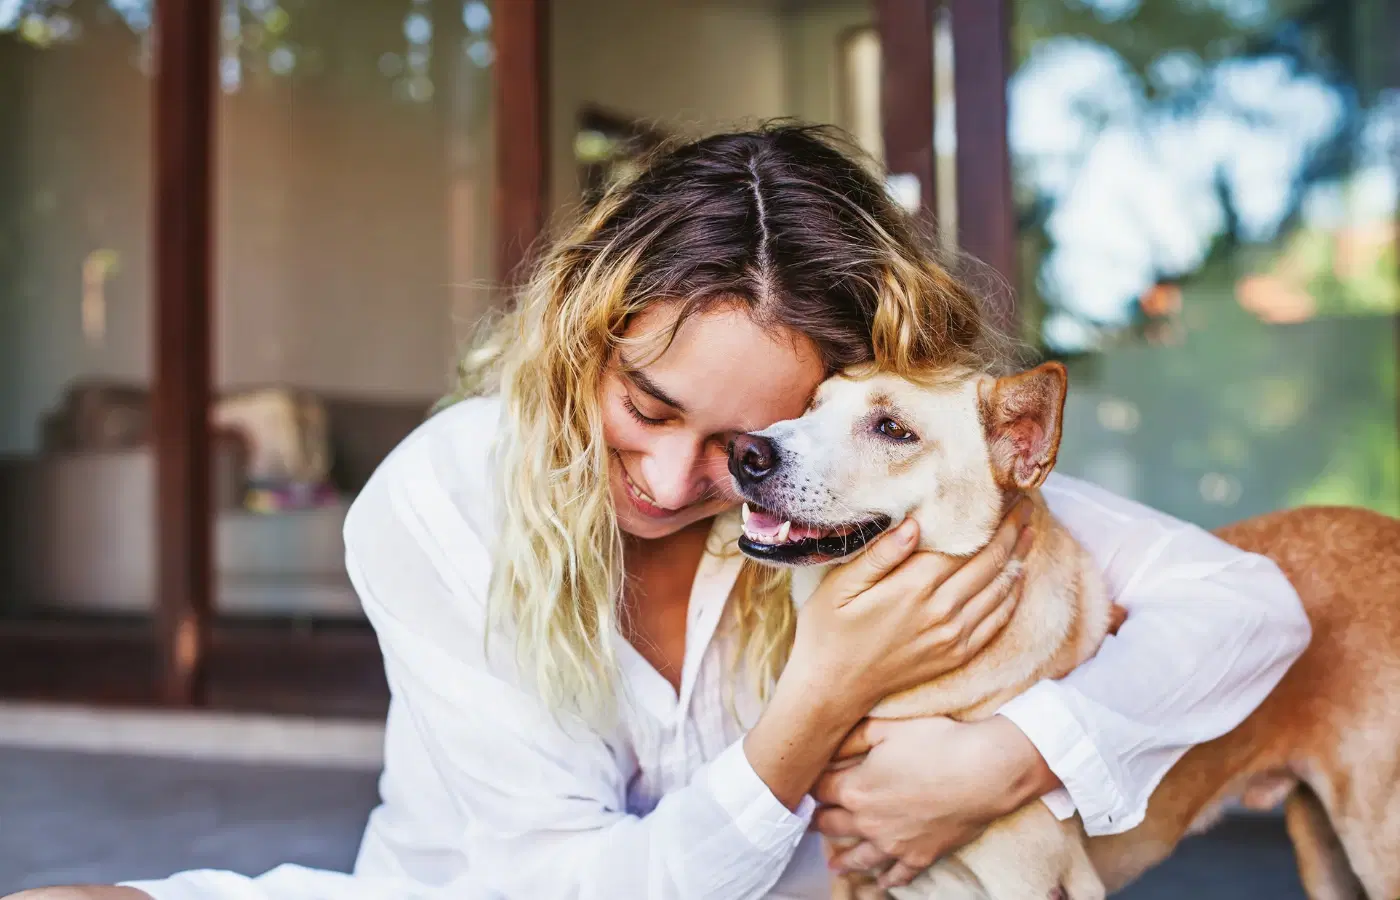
[784,500,1032,724]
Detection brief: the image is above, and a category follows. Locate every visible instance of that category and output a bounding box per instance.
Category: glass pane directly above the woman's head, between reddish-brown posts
[549,0,881,207]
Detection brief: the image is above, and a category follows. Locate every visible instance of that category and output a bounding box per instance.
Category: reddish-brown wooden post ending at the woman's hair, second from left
[491,0,549,284]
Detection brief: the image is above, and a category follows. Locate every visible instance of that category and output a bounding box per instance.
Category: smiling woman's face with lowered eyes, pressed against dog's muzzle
[602,304,825,539]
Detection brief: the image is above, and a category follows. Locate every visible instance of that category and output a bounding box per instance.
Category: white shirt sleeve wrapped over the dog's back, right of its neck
[1000,477,1312,836]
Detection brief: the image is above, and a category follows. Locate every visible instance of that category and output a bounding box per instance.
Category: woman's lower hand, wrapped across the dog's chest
[812,715,1058,887]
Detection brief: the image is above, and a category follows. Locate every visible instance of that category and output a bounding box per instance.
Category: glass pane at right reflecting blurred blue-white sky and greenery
[1009,0,1400,525]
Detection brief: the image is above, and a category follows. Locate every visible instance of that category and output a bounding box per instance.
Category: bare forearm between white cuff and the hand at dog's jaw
[743,670,862,809]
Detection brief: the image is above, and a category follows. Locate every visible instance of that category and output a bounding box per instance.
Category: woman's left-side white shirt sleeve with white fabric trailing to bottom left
[133,417,812,900]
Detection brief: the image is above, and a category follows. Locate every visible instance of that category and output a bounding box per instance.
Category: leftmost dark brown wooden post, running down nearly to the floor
[151,0,217,705]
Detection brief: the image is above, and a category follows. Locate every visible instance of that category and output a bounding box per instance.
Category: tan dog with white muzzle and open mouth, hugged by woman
[731,364,1400,900]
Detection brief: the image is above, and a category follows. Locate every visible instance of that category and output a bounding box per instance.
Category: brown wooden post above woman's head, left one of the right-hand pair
[875,0,938,221]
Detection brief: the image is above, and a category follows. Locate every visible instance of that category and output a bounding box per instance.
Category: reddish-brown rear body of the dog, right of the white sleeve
[1088,507,1400,900]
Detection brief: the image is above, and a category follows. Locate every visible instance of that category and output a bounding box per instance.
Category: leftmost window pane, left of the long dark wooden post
[0,3,155,617]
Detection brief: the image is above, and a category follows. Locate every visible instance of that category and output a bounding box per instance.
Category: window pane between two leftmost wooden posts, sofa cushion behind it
[207,0,493,619]
